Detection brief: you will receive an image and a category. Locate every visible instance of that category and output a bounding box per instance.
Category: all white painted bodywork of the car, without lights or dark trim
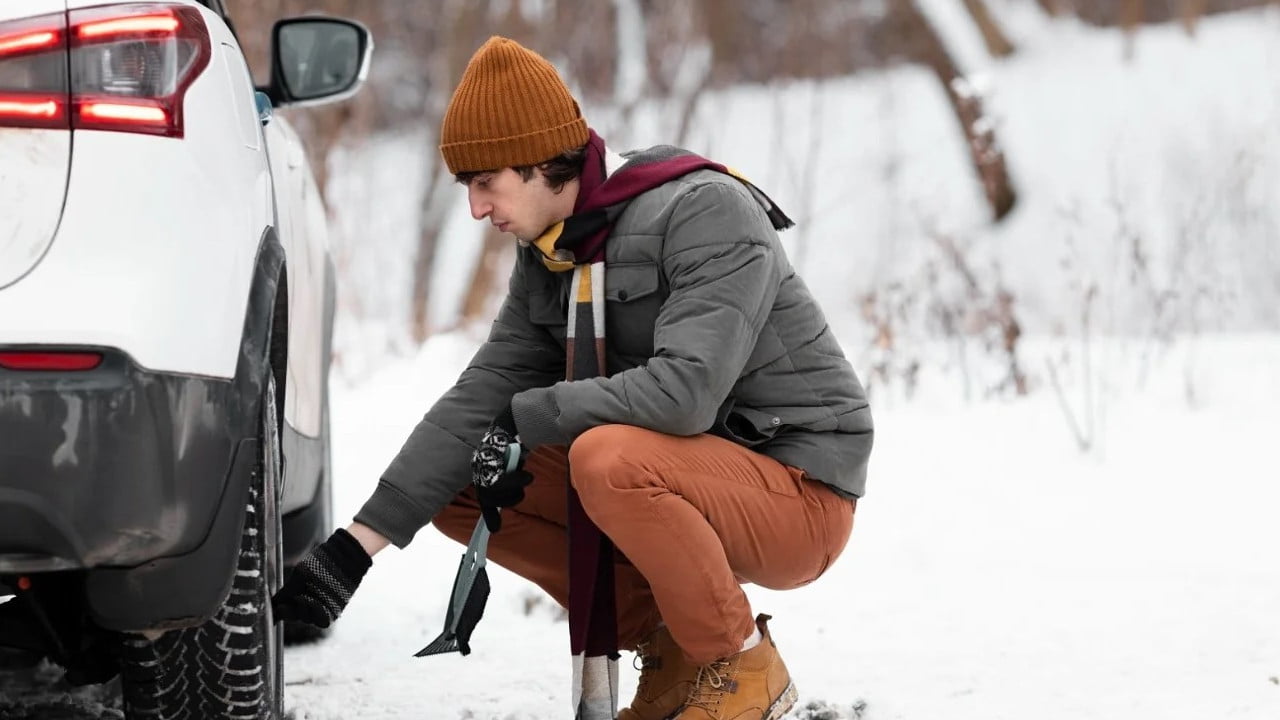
[0,0,328,437]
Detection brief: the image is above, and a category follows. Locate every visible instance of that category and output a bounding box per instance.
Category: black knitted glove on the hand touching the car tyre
[271,528,374,628]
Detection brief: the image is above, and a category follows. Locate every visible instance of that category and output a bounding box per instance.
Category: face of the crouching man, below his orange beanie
[467,168,577,240]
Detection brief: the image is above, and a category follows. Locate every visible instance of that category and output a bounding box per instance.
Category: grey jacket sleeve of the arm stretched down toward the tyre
[356,251,564,547]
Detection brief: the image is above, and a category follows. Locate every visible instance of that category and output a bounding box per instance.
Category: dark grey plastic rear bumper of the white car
[0,350,255,574]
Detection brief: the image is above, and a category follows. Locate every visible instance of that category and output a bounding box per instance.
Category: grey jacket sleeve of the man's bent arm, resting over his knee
[512,182,785,445]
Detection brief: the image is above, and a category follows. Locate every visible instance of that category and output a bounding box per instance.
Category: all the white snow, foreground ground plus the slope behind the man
[285,7,1280,720]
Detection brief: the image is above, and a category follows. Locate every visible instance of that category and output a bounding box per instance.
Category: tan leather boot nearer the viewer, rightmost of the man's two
[676,615,796,720]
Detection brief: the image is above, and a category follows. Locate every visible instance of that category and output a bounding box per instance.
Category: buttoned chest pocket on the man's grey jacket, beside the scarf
[604,263,666,359]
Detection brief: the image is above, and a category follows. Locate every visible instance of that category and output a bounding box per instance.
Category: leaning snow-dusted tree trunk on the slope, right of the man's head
[891,0,1018,220]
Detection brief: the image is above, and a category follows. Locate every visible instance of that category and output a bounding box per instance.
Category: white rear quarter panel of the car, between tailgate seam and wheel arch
[0,7,273,378]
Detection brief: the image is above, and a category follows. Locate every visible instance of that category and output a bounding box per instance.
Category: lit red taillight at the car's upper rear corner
[0,3,212,137]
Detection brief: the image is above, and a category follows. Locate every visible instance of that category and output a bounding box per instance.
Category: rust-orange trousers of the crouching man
[434,425,856,665]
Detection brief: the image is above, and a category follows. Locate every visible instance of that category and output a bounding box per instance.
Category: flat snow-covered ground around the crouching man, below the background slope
[277,334,1280,720]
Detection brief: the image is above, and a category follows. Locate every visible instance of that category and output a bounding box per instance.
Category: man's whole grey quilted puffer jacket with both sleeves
[356,170,873,547]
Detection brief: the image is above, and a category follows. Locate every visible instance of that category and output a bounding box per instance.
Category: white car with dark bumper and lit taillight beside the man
[0,0,372,717]
